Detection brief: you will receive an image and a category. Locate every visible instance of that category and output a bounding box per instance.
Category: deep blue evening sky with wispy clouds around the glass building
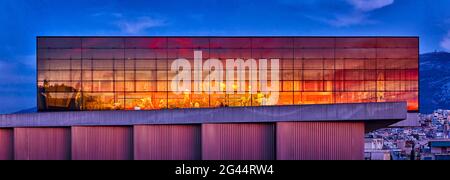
[0,0,450,113]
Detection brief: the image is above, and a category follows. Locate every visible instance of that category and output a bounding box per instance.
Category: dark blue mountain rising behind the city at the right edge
[419,52,450,114]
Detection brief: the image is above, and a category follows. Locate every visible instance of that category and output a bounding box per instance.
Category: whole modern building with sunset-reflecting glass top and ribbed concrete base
[0,37,419,160]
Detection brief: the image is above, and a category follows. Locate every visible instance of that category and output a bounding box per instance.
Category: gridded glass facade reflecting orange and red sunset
[37,37,419,111]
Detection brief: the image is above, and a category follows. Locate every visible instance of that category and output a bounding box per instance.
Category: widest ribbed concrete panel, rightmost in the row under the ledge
[276,122,364,160]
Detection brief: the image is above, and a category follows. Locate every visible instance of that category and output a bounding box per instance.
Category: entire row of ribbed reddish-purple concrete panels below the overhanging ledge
[0,122,364,160]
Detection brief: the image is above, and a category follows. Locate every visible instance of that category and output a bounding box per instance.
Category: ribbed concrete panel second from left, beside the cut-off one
[14,128,70,160]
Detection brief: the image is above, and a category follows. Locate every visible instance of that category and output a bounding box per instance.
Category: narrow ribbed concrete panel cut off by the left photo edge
[0,129,14,160]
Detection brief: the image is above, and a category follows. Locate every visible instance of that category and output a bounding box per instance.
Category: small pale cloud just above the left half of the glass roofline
[115,17,165,35]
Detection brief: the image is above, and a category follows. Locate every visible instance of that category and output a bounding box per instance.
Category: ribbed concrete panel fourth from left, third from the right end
[133,125,201,160]
